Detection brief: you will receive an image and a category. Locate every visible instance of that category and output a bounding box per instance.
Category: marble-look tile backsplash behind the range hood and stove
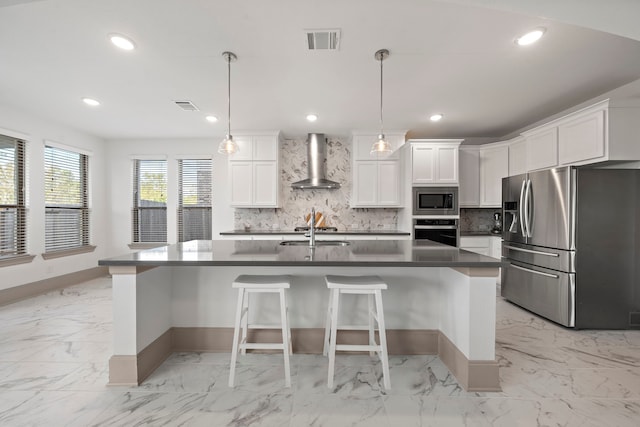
[234,139,398,230]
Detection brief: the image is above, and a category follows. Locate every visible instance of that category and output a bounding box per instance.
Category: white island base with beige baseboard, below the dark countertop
[109,265,500,391]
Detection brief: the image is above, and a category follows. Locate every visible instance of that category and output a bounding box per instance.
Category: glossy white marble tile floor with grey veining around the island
[0,278,640,427]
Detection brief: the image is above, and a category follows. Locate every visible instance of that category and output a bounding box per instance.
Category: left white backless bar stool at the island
[229,274,292,387]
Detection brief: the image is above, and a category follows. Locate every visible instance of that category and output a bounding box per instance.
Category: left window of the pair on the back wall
[132,159,167,243]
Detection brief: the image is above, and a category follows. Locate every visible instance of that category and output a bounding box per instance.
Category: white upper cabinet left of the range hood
[229,133,280,208]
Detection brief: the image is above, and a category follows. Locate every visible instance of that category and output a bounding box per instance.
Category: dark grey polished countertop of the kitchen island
[98,240,508,268]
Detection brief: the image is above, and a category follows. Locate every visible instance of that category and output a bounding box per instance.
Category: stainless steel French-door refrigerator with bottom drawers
[501,167,640,329]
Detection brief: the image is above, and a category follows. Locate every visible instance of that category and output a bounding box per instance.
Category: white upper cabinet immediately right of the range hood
[351,132,405,208]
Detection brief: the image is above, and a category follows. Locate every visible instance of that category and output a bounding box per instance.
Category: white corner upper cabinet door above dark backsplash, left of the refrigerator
[480,146,509,207]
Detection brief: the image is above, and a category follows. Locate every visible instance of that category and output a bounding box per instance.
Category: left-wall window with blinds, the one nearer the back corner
[44,145,94,259]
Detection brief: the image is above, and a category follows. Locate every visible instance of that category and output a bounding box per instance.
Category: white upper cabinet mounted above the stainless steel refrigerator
[522,100,640,170]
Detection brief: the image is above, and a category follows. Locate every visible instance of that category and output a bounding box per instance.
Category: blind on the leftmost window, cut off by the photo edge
[0,135,27,259]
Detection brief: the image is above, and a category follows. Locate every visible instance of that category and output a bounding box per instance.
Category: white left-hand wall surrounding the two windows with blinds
[0,105,109,290]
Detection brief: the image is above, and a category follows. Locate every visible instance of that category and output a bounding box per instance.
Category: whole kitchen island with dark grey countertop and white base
[99,240,505,391]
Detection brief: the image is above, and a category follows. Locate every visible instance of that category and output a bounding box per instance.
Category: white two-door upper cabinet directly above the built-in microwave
[408,139,462,185]
